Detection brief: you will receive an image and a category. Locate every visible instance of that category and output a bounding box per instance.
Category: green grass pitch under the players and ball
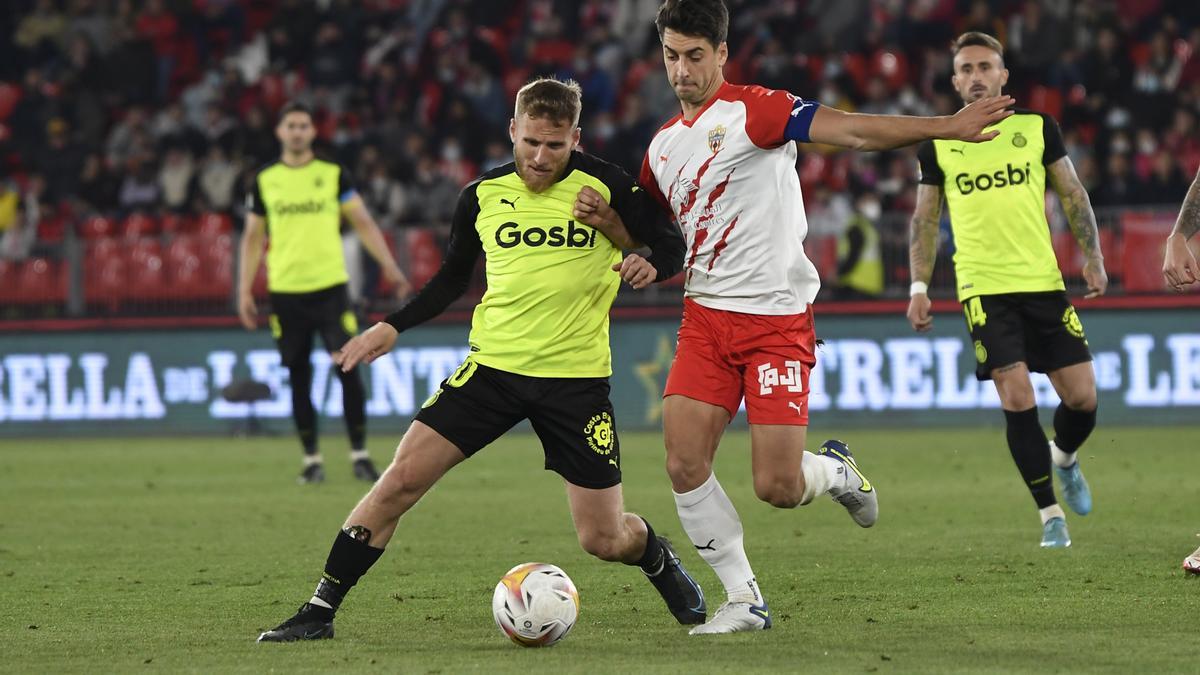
[0,420,1200,674]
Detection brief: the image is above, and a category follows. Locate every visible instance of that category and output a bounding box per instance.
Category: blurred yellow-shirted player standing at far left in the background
[238,103,409,483]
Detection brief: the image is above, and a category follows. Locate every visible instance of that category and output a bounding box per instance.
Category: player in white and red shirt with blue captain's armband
[641,0,1013,634]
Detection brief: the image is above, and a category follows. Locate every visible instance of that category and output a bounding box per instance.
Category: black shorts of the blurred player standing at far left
[270,283,359,368]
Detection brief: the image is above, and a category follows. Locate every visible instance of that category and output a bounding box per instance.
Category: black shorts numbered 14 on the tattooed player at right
[962,291,1092,380]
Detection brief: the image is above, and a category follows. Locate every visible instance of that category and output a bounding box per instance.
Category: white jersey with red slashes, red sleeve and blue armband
[640,83,821,315]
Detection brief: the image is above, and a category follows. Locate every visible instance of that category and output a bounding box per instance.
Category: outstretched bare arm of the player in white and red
[809,95,1014,151]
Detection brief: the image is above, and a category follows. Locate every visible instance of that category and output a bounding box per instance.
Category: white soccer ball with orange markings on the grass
[492,562,580,647]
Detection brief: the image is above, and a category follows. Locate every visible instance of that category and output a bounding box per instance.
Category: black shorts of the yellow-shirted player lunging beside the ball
[416,358,620,489]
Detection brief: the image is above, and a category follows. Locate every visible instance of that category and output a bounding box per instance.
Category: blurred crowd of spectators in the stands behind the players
[0,0,1200,260]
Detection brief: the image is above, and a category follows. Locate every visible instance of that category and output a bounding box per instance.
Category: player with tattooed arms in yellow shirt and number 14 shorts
[908,32,1108,548]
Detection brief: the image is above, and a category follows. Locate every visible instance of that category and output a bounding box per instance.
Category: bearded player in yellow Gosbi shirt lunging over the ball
[259,79,706,641]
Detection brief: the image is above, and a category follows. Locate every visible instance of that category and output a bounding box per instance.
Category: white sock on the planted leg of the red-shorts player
[674,473,758,602]
